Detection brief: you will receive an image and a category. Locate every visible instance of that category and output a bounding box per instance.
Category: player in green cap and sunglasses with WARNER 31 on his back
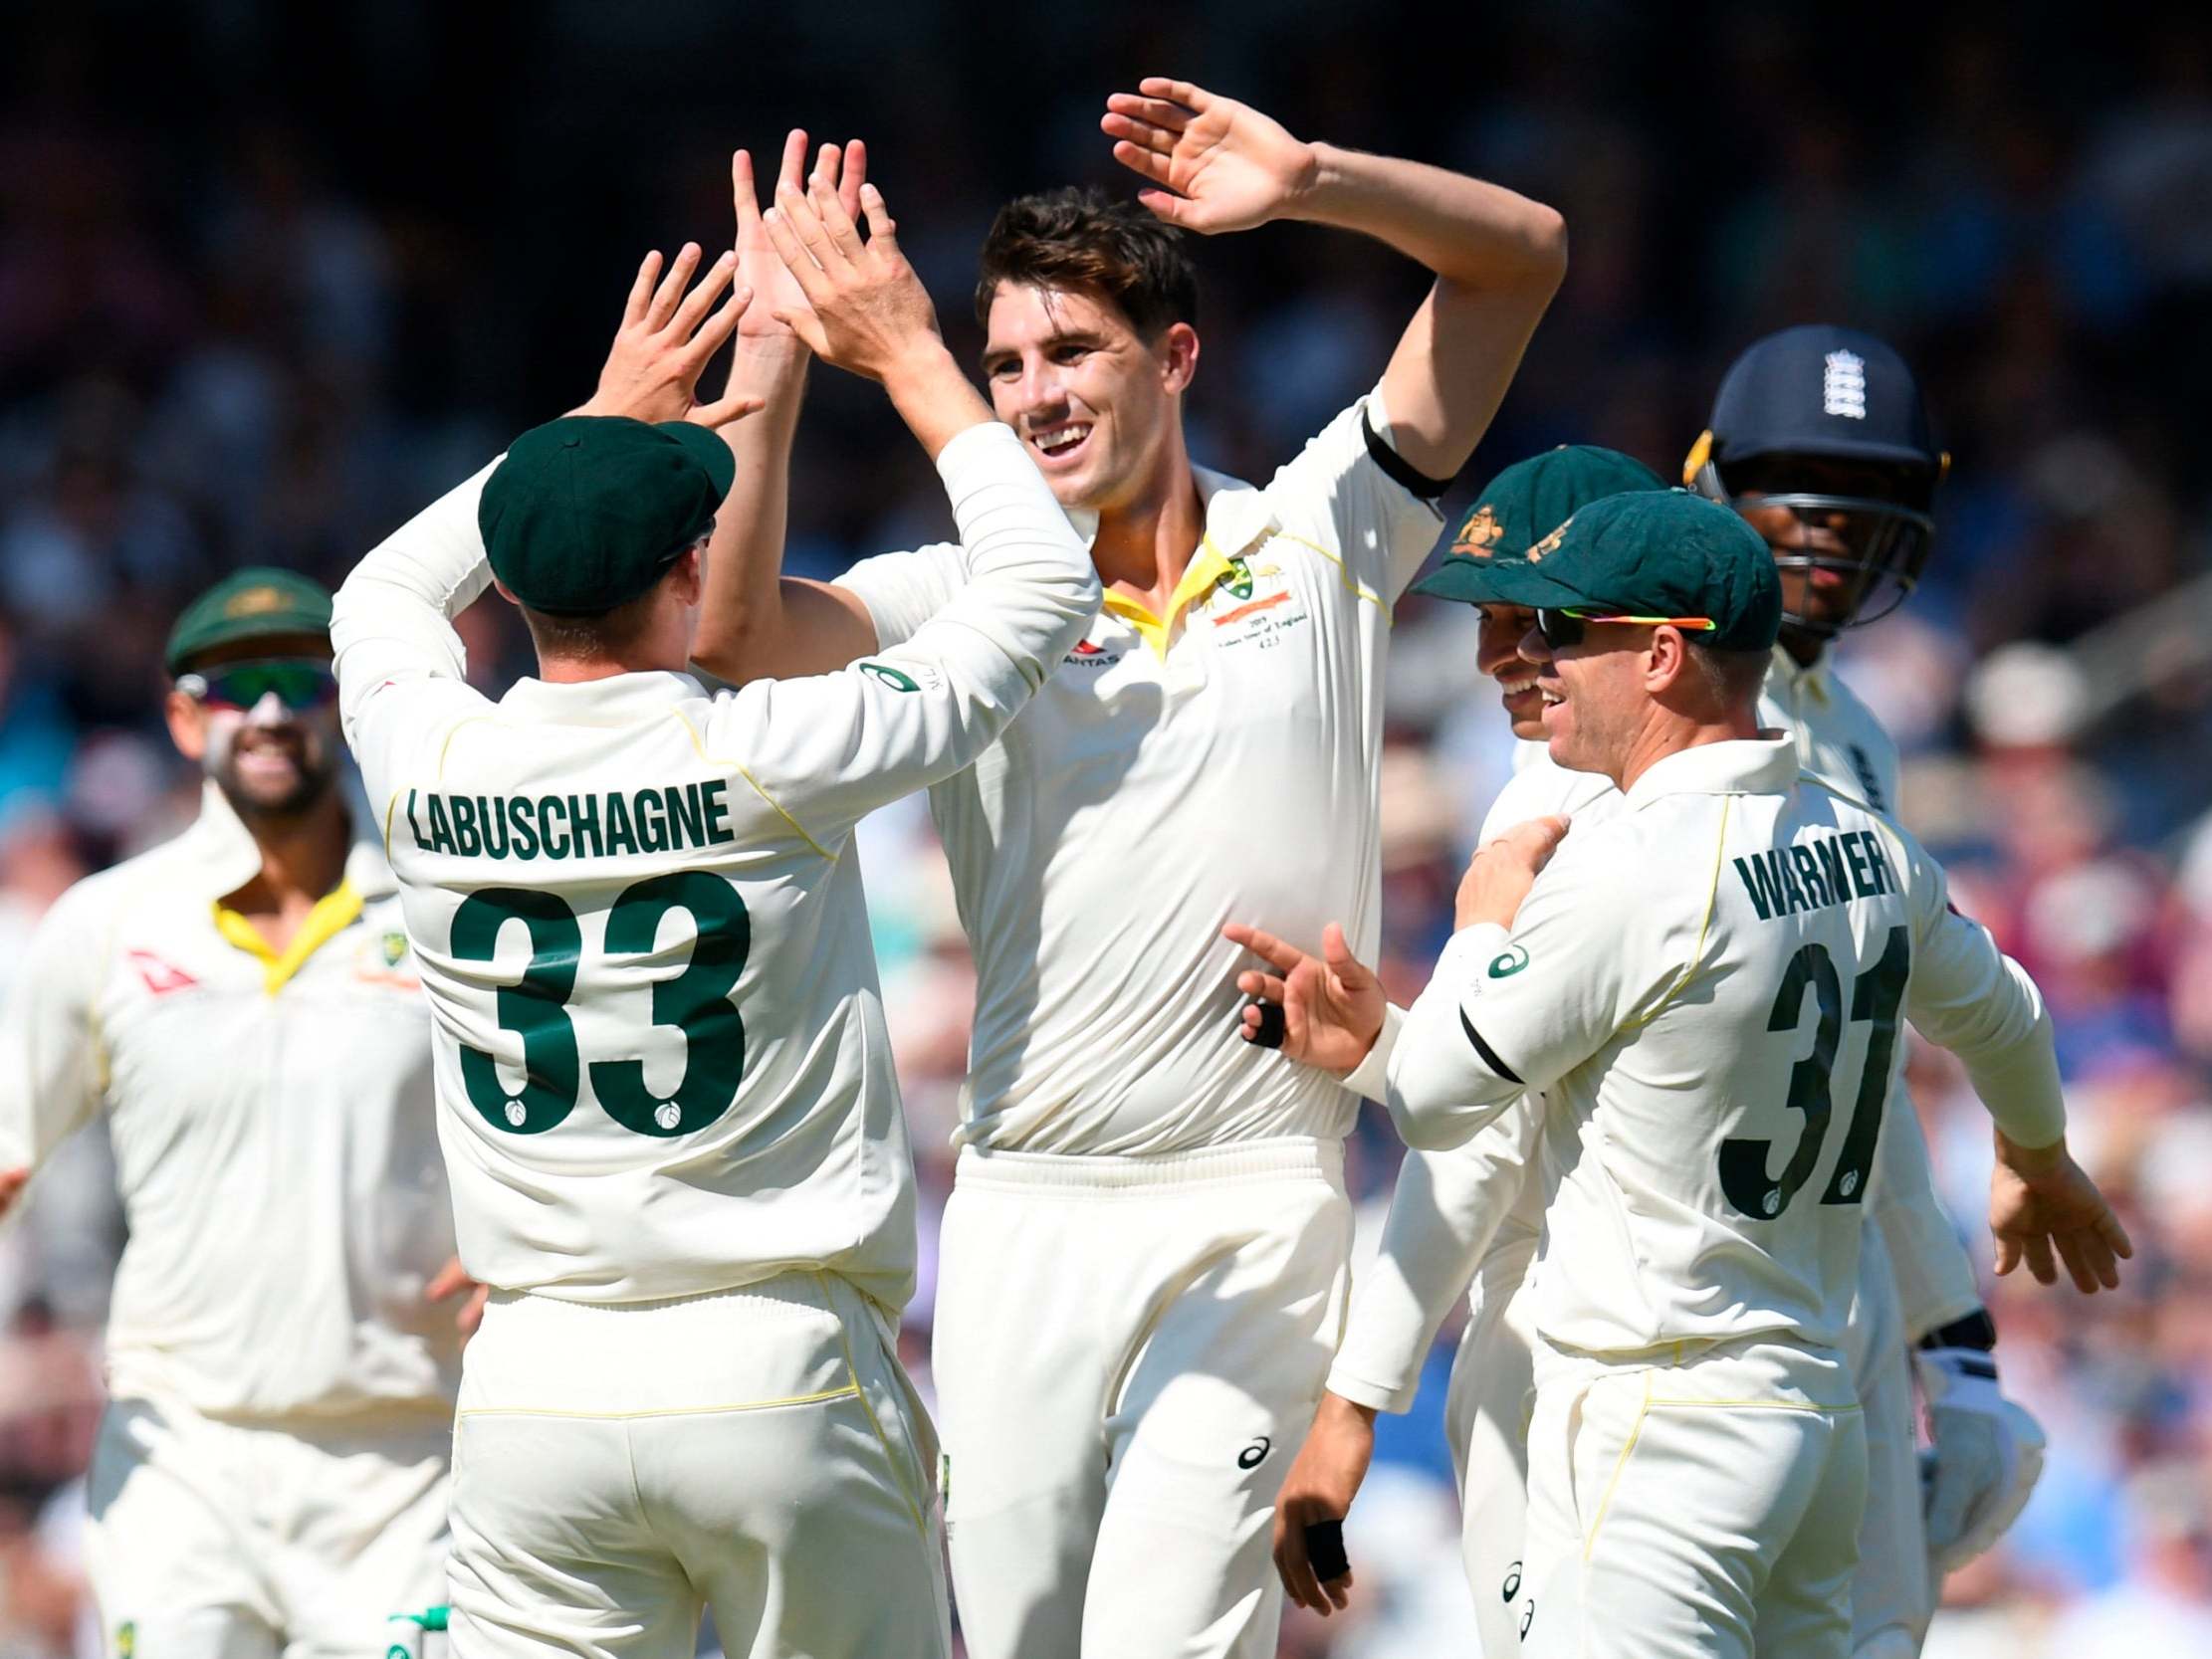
[1247,491,2128,1655]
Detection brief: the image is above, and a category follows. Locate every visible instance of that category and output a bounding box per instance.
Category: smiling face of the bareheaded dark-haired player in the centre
[983,284,1199,514]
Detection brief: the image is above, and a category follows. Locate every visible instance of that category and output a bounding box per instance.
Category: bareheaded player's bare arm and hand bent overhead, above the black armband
[1099,76,1566,480]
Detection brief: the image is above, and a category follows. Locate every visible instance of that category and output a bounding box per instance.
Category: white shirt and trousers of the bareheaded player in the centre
[843,396,1440,1659]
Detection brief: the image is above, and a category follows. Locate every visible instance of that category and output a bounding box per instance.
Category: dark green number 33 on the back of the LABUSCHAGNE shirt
[454,870,752,1137]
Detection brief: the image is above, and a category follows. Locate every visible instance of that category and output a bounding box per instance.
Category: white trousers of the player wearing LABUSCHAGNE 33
[449,1272,951,1659]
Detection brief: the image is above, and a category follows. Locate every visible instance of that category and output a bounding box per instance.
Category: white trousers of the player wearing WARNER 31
[1522,1341,1867,1659]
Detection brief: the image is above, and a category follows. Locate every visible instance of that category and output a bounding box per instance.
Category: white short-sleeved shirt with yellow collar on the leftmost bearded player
[0,783,460,1422]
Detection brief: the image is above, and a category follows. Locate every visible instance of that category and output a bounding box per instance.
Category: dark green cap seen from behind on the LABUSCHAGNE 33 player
[476,416,737,617]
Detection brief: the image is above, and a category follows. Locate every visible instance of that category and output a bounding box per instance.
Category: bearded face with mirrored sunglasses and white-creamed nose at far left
[166,635,338,821]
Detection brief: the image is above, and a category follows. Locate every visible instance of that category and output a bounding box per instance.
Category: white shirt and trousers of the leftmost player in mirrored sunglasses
[0,783,460,1659]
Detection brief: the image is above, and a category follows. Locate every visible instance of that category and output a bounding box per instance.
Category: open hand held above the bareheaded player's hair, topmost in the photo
[1099,76,1321,237]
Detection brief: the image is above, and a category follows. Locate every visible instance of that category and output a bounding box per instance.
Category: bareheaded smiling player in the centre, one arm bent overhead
[701,80,1564,1659]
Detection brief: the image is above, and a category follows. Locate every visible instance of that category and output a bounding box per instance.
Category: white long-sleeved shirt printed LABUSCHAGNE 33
[332,423,1099,1308]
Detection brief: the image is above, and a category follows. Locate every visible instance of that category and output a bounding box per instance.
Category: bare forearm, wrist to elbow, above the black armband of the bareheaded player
[1285,143,1566,295]
